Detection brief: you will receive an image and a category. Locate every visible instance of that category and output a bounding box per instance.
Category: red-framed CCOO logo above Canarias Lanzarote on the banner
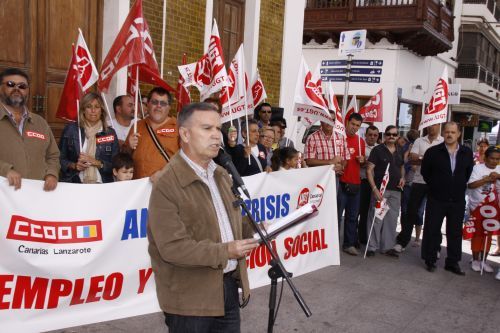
[7,215,102,244]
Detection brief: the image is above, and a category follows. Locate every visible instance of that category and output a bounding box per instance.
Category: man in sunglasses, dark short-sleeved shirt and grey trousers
[366,125,404,258]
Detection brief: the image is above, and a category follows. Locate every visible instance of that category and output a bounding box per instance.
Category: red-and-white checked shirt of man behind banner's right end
[304,129,351,160]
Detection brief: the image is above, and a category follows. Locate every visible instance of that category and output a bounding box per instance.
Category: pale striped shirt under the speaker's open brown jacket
[180,149,238,273]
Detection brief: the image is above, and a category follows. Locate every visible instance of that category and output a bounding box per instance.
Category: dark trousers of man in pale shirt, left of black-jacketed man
[396,183,427,247]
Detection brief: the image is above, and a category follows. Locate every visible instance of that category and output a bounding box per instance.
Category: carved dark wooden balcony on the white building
[303,0,454,56]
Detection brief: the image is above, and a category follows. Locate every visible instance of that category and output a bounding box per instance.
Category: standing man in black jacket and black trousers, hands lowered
[421,122,474,275]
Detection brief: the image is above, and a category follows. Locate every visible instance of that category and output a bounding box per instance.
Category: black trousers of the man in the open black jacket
[421,197,465,265]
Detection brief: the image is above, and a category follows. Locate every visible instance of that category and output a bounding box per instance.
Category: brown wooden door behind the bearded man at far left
[0,0,103,136]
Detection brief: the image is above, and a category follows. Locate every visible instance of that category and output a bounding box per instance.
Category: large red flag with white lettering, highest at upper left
[98,0,159,92]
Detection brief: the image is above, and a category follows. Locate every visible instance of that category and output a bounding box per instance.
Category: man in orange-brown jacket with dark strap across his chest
[125,87,179,182]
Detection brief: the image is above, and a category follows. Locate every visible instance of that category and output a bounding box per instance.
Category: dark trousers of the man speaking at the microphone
[165,274,241,333]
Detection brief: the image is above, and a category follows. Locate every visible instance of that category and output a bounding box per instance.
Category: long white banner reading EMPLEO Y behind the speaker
[0,166,339,332]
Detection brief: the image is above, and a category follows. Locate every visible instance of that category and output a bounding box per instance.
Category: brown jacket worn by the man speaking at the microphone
[148,154,252,316]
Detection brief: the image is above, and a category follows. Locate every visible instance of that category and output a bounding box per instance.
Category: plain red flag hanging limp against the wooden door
[56,45,81,121]
